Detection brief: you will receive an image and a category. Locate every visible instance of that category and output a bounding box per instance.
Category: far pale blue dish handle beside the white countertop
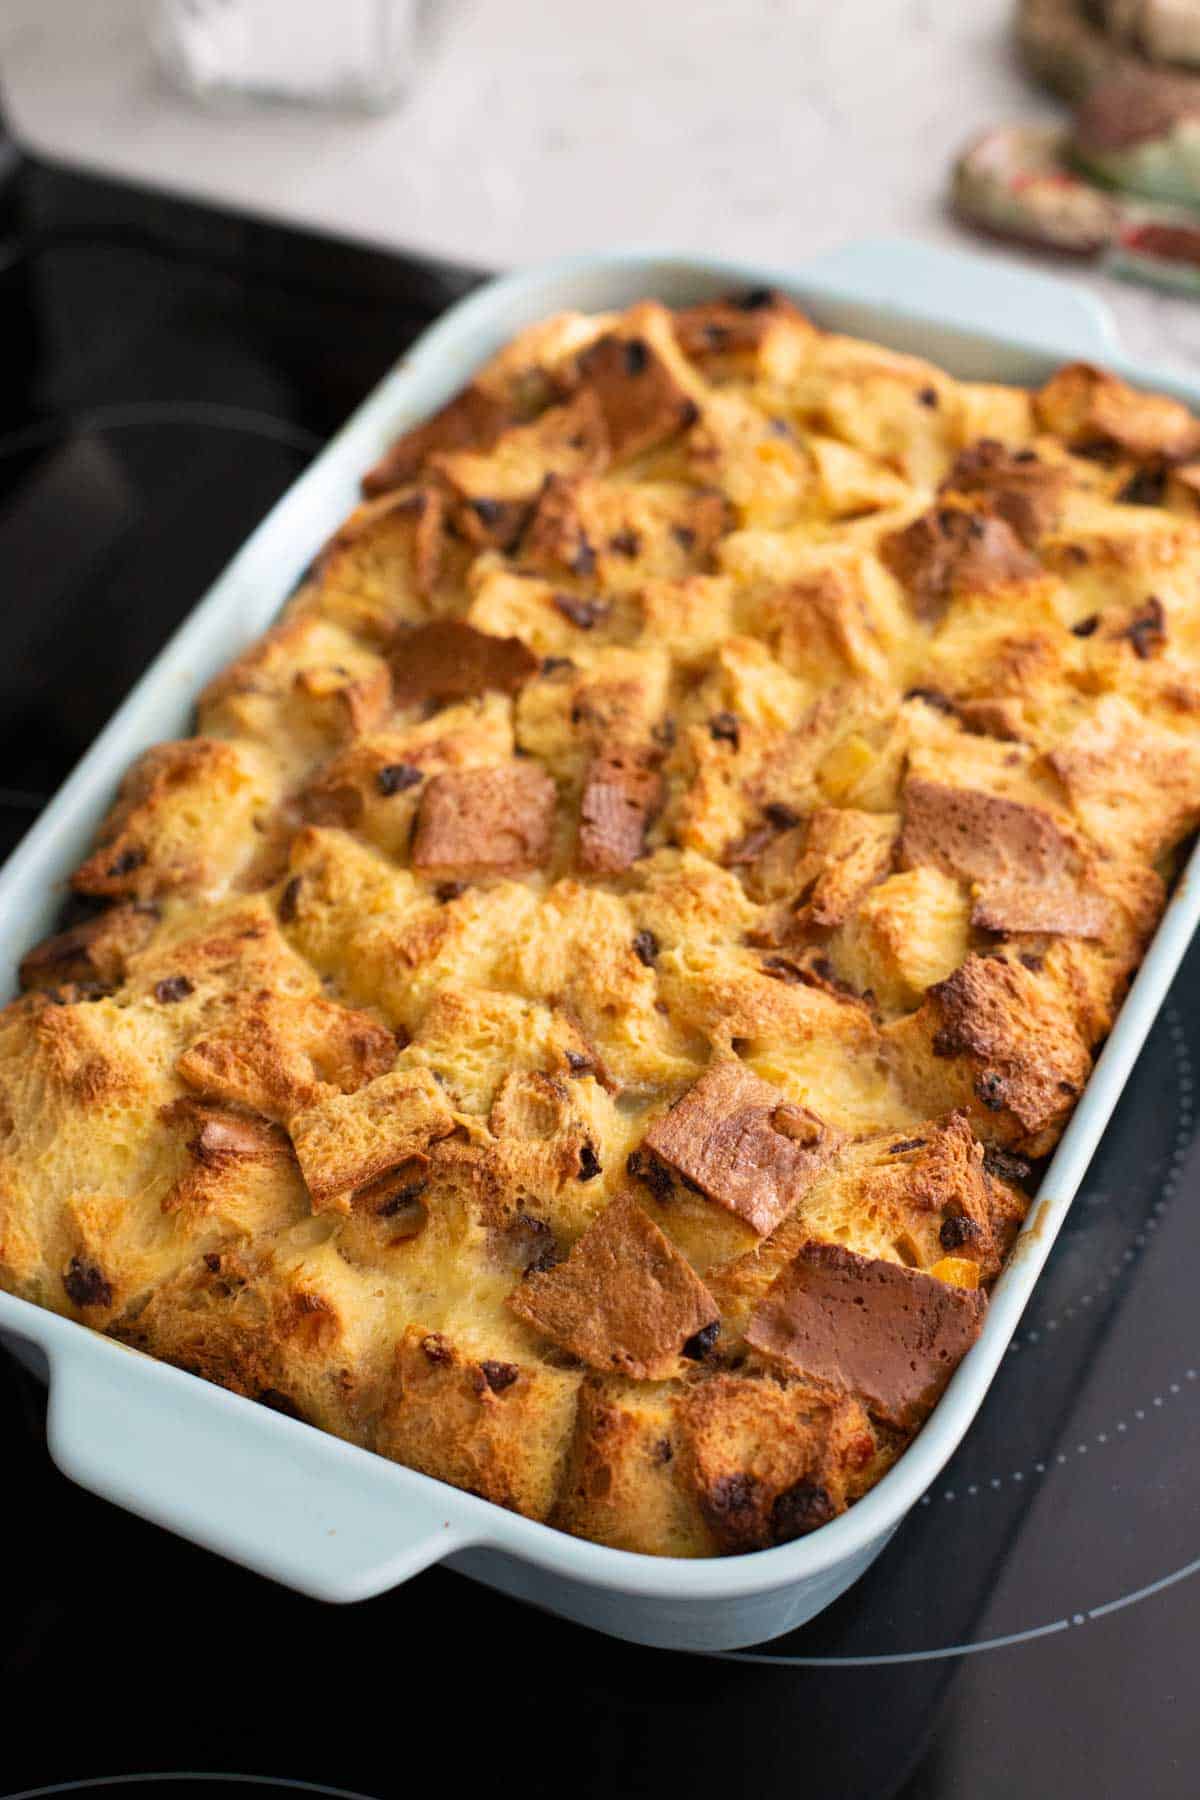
[797,238,1121,360]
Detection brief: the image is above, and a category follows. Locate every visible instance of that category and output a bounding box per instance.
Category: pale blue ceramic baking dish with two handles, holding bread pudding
[0,243,1200,1649]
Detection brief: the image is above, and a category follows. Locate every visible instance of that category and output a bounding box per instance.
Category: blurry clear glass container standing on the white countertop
[153,0,421,112]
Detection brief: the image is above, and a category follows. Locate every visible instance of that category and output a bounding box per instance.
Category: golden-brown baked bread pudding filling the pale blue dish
[0,293,1200,1555]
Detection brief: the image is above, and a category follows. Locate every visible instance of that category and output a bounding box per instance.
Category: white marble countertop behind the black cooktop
[0,0,1200,373]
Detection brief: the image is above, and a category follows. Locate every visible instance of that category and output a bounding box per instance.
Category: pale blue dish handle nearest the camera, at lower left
[47,1334,479,1600]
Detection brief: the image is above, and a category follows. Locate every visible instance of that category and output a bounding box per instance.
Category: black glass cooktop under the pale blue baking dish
[0,136,1200,1800]
